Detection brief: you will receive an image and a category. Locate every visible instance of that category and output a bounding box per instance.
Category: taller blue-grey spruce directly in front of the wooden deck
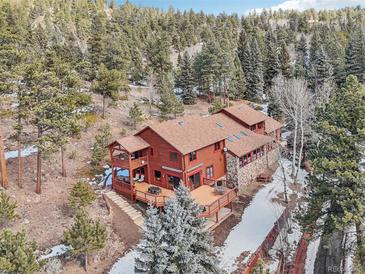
[162,186,219,273]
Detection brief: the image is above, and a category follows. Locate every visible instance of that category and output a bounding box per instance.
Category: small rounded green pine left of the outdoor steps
[69,180,96,209]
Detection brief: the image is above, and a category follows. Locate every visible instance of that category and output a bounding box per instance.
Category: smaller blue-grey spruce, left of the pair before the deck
[135,206,167,274]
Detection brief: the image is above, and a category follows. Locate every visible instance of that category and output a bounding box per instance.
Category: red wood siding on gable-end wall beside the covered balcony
[138,128,182,187]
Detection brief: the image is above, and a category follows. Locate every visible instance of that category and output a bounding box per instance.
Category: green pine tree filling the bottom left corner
[0,229,43,273]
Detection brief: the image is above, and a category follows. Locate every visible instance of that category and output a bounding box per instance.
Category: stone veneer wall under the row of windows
[227,147,279,189]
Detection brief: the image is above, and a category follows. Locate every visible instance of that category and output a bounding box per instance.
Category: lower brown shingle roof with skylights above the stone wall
[210,113,274,157]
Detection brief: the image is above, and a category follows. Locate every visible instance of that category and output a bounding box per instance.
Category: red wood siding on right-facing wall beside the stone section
[184,141,226,187]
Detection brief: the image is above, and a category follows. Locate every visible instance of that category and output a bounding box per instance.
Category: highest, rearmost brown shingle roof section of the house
[221,104,268,126]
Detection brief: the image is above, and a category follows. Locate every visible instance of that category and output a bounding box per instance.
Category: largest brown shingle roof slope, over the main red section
[137,115,226,155]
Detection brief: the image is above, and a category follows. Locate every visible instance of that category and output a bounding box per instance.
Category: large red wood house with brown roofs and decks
[109,105,281,226]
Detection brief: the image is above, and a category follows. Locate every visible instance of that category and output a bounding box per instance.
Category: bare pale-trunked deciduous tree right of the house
[271,75,314,182]
